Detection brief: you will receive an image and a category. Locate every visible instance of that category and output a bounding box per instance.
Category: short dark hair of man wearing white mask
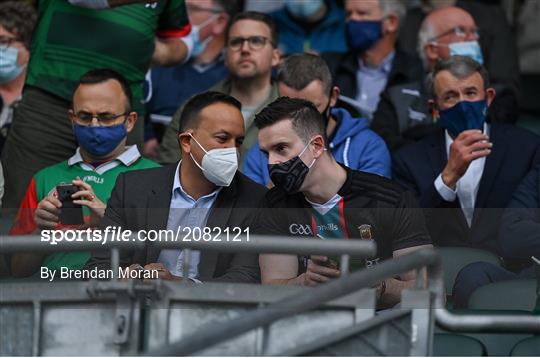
[178,91,242,133]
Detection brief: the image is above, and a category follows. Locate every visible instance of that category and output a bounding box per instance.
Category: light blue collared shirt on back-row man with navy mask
[356,51,396,113]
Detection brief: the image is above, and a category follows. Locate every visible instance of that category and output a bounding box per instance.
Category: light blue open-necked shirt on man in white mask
[158,162,221,279]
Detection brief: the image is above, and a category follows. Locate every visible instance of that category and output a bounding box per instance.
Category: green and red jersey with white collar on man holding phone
[10,146,159,269]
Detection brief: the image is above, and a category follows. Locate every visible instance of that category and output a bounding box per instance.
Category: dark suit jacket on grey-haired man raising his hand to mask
[393,123,540,256]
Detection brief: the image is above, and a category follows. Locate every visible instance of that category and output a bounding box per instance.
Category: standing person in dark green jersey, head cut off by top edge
[2,0,190,208]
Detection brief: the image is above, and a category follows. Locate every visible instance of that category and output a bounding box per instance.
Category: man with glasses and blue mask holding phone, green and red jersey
[10,69,157,277]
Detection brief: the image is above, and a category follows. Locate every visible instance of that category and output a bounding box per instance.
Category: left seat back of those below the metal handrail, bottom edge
[433,333,486,357]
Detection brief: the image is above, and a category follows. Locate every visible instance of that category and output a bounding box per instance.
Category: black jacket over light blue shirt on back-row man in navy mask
[321,48,423,116]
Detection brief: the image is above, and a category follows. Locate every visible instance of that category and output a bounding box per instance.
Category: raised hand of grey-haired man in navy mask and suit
[441,129,493,190]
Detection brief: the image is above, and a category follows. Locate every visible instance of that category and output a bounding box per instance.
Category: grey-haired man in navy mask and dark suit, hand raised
[393,56,540,255]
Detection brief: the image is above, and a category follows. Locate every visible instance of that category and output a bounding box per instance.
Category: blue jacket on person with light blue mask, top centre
[270,0,348,55]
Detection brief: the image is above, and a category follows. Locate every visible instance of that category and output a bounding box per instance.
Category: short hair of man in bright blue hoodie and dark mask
[277,53,332,94]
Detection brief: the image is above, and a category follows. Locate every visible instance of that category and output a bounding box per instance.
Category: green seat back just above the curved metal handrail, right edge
[469,279,536,311]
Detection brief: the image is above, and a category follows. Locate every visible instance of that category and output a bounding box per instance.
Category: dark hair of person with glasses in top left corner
[0,1,37,49]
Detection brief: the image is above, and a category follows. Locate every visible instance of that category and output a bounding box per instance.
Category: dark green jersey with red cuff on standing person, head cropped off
[26,0,191,114]
